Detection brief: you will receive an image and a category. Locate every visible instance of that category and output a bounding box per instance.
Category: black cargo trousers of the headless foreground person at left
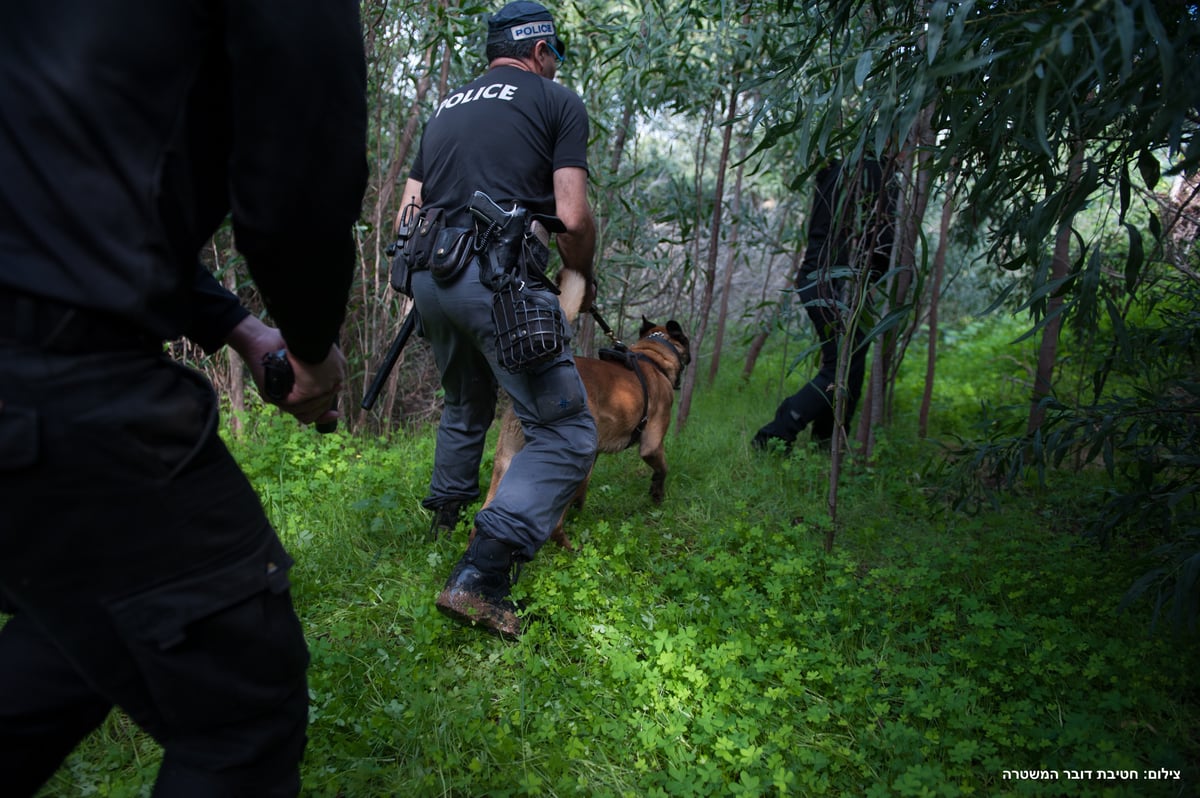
[0,338,308,797]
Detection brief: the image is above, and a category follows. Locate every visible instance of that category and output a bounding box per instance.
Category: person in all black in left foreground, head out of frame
[0,0,366,797]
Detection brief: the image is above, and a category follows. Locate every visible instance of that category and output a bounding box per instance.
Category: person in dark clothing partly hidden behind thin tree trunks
[751,160,895,449]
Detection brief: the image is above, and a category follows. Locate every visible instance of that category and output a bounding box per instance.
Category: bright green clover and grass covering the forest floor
[16,319,1200,798]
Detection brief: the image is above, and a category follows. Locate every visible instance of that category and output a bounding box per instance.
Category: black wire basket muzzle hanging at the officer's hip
[492,281,568,374]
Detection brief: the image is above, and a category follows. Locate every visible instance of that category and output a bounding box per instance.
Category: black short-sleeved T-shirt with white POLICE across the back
[409,66,588,227]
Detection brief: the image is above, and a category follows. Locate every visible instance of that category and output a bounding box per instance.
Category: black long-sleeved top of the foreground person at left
[0,0,366,362]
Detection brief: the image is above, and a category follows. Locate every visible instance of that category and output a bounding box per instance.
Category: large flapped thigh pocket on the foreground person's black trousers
[109,535,308,730]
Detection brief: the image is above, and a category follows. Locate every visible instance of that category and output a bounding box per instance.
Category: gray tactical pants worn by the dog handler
[413,263,596,559]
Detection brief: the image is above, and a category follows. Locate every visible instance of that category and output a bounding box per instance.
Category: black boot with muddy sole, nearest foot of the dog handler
[436,535,521,640]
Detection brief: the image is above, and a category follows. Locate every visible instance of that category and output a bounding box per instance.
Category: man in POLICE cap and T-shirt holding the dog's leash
[402,1,596,637]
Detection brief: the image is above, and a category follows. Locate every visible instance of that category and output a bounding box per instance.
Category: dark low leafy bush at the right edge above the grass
[938,273,1200,632]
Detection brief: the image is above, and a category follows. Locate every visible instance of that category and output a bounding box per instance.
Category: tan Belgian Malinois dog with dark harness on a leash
[484,317,691,548]
